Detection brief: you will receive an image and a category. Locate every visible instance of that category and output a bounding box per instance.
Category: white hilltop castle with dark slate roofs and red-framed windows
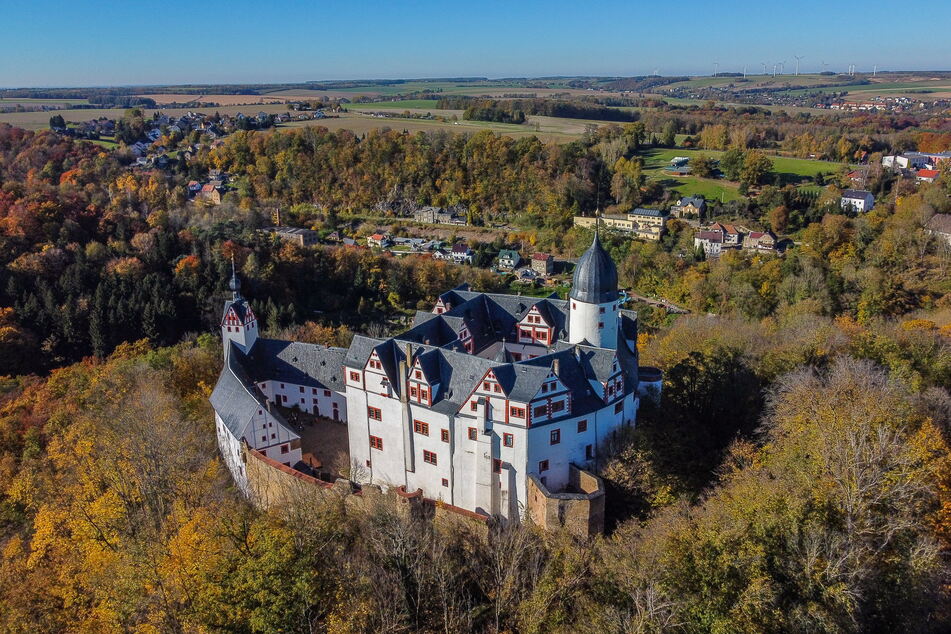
[211,233,659,520]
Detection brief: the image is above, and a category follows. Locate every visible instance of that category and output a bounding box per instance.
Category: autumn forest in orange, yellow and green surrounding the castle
[0,110,951,633]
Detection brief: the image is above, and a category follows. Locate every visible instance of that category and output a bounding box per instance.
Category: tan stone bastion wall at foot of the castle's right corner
[528,465,604,537]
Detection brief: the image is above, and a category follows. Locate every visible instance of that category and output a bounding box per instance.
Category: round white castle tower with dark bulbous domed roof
[568,225,620,349]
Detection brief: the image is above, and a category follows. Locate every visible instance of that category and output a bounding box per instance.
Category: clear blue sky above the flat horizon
[0,0,951,87]
